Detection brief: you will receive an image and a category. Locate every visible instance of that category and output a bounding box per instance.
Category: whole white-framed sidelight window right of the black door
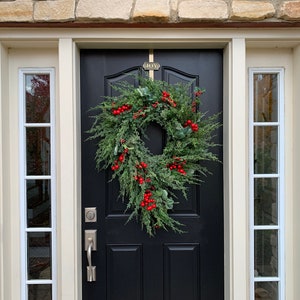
[249,68,285,300]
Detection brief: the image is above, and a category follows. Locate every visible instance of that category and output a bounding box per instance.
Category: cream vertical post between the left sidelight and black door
[57,39,82,300]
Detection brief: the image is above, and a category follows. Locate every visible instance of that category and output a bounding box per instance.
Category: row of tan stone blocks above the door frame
[0,0,300,26]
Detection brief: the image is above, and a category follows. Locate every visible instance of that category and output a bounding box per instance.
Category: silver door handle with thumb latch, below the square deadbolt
[84,230,97,282]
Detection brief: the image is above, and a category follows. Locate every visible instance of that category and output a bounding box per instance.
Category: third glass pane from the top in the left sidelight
[26,180,51,227]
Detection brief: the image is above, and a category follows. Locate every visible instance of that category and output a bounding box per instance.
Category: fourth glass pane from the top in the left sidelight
[28,232,51,279]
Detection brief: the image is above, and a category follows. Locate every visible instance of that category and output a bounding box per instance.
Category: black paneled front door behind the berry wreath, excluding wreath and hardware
[80,50,224,300]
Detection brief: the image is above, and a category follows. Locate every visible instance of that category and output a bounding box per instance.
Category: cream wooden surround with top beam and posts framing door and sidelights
[0,28,300,300]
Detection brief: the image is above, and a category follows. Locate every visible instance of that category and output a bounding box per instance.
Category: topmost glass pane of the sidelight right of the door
[253,74,278,122]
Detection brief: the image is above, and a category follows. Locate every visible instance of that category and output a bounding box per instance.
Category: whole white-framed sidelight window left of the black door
[19,69,56,300]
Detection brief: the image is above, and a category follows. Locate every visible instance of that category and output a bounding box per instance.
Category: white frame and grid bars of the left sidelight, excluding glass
[19,68,57,300]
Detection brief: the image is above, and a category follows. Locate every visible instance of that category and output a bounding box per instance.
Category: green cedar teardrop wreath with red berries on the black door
[88,78,220,236]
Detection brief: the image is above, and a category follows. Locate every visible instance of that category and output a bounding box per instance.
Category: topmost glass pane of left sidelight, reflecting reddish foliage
[25,74,50,123]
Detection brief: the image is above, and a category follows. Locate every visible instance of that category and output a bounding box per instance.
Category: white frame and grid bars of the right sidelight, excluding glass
[249,68,285,300]
